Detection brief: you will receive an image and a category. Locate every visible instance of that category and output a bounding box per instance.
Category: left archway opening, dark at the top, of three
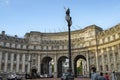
[41,56,52,77]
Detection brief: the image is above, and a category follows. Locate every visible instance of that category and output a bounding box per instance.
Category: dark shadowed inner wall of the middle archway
[57,56,68,77]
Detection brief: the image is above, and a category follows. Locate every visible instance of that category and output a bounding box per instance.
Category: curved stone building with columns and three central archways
[0,24,120,77]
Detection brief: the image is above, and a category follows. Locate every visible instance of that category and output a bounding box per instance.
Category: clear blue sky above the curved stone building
[0,0,120,37]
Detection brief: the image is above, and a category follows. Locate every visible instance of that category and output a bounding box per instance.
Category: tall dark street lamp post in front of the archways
[65,8,74,80]
